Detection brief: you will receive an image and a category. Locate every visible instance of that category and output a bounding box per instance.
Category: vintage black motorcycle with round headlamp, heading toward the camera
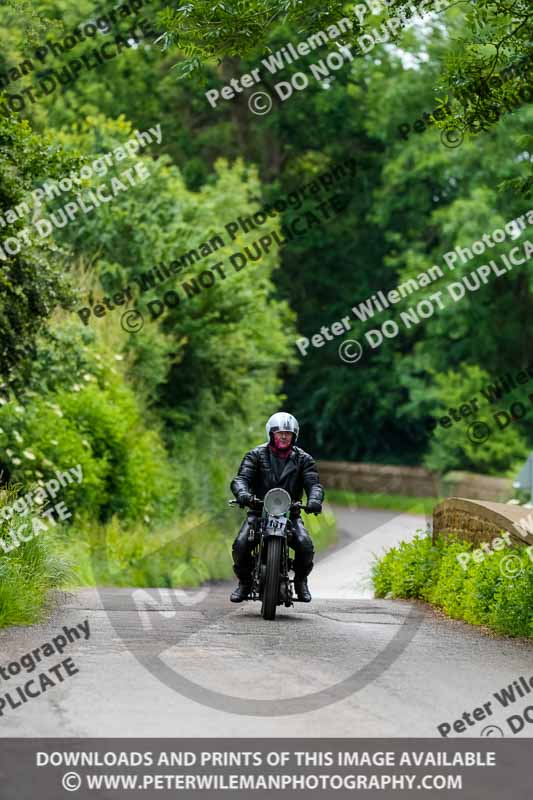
[229,489,309,620]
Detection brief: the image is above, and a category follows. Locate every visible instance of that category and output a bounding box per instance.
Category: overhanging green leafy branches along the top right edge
[158,0,532,162]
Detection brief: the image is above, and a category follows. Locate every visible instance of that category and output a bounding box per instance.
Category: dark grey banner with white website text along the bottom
[0,738,533,800]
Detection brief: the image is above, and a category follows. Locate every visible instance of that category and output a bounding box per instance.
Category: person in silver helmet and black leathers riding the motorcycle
[230,411,324,603]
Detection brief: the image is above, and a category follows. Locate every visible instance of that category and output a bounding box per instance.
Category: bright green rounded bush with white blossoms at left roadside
[0,328,173,519]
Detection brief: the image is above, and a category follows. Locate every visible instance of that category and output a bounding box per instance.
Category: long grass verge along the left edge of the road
[0,494,337,628]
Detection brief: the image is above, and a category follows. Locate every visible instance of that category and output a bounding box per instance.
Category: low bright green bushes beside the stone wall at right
[373,536,533,637]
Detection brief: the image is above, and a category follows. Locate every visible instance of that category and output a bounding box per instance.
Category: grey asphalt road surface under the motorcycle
[0,508,533,737]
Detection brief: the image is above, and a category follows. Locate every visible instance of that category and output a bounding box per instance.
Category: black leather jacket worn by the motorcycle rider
[231,444,324,503]
